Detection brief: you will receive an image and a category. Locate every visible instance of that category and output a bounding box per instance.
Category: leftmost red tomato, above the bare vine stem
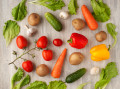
[16,35,28,49]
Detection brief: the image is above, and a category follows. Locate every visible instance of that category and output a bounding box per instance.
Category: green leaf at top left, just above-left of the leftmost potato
[12,0,27,21]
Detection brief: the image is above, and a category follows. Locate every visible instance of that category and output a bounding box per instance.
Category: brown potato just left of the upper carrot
[72,18,85,30]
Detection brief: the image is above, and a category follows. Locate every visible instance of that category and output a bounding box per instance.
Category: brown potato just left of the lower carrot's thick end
[36,64,49,77]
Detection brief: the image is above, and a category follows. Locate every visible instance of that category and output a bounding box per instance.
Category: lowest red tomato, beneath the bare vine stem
[22,60,33,72]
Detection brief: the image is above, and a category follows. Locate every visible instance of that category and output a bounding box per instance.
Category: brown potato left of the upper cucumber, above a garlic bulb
[28,13,40,26]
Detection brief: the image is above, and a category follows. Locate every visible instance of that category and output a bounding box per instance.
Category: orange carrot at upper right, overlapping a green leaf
[81,5,98,30]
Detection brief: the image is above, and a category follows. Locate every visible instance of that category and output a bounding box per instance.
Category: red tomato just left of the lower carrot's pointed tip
[42,50,53,61]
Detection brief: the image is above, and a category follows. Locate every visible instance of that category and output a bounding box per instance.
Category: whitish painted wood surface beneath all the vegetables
[0,0,120,89]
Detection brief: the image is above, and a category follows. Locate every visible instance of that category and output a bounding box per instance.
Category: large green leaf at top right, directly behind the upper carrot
[91,0,111,22]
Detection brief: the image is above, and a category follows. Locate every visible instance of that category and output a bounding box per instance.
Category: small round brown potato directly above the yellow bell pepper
[95,31,107,42]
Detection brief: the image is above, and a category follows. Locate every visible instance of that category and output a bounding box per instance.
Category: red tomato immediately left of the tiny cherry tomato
[36,36,48,48]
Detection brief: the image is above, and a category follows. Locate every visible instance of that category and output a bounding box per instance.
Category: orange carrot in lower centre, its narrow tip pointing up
[51,48,67,78]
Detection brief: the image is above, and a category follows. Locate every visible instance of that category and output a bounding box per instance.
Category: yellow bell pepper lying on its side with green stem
[90,44,110,61]
